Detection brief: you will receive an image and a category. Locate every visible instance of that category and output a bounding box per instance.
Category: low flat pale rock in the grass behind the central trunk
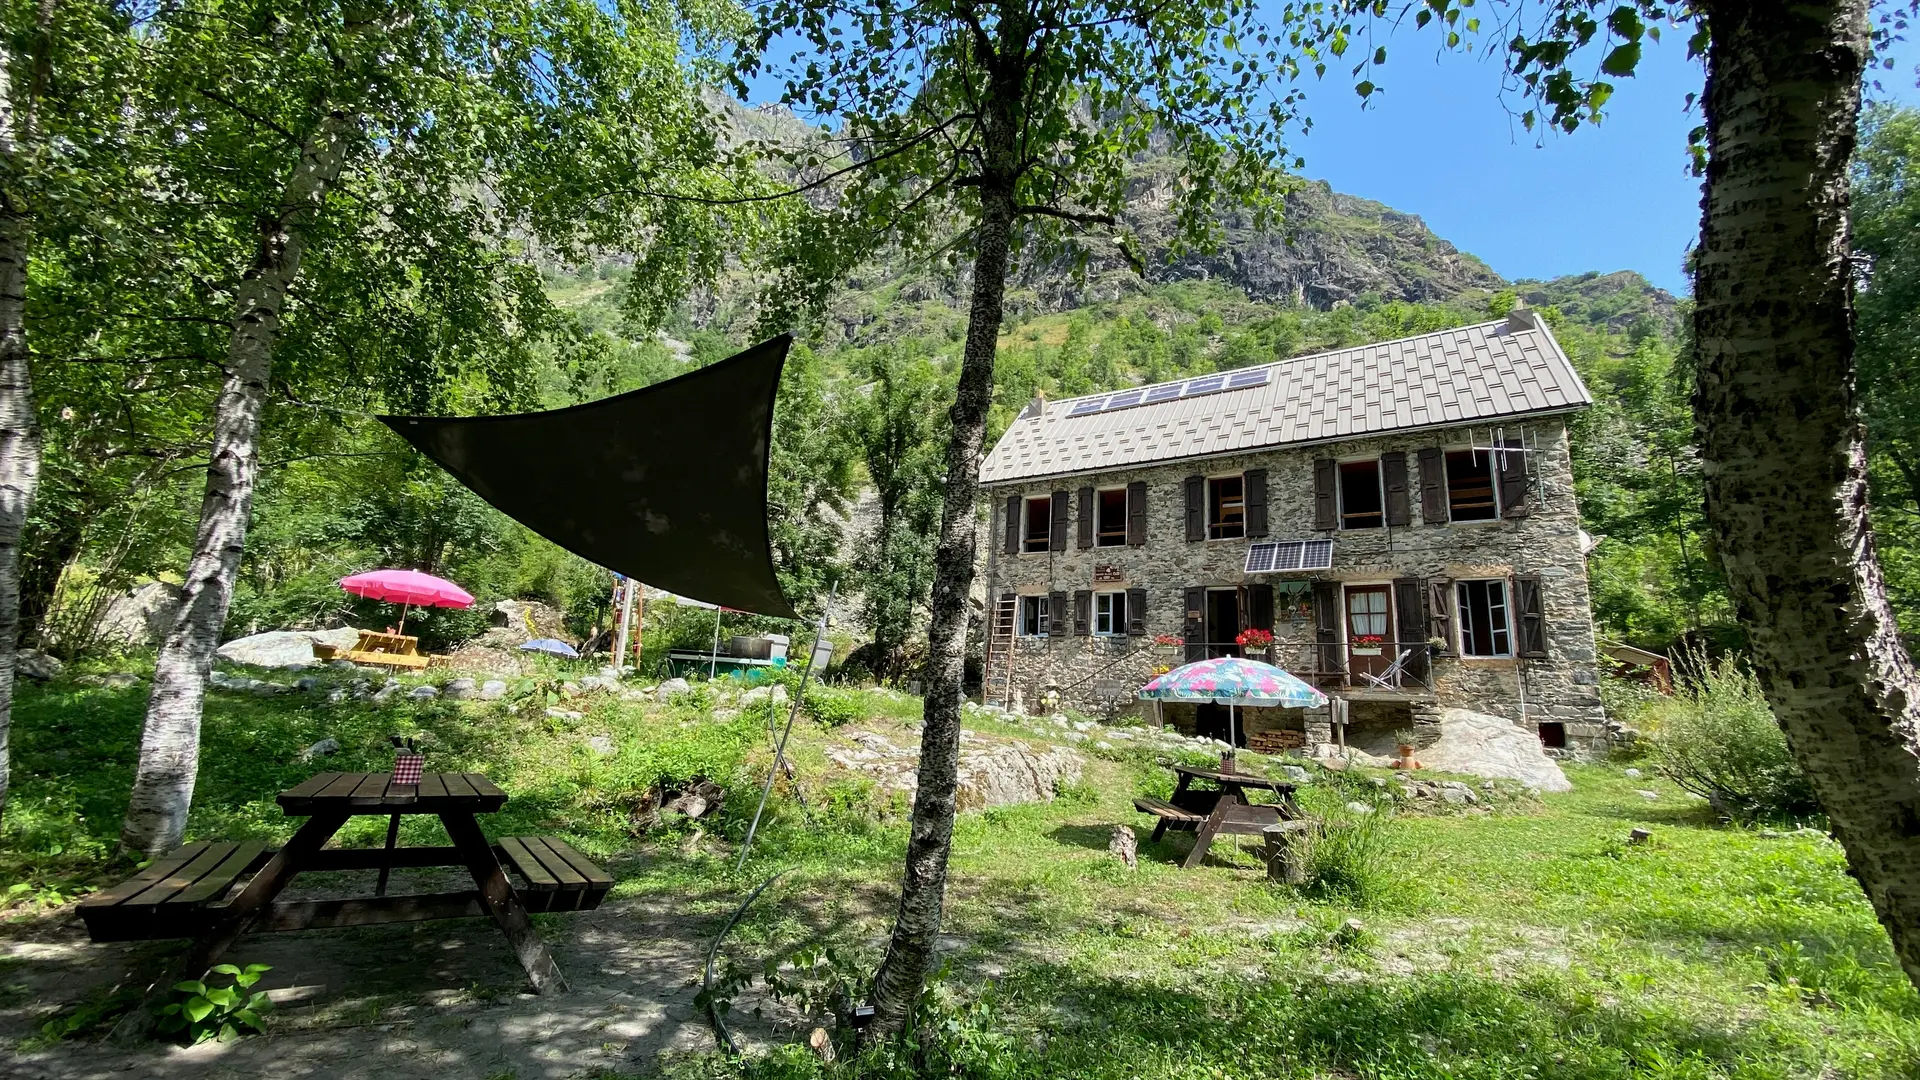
[828,730,1085,811]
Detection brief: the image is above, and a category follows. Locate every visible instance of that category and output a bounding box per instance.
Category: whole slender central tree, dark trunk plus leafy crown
[741,0,1292,1038]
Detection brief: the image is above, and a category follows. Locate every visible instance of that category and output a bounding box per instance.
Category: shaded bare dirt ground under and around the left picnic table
[0,883,787,1080]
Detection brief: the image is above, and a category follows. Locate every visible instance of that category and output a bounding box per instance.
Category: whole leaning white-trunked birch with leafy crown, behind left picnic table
[123,0,756,853]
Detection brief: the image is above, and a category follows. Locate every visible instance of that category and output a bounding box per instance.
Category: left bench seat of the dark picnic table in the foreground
[81,840,273,942]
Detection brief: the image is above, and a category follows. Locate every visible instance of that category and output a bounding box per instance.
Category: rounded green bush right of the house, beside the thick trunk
[1647,651,1820,822]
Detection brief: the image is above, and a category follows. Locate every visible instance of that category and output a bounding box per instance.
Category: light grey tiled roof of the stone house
[979,309,1594,484]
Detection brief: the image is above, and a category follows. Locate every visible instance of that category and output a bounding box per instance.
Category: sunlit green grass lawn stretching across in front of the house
[0,664,1920,1080]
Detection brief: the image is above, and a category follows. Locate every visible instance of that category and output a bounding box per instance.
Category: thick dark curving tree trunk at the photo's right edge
[1693,0,1920,986]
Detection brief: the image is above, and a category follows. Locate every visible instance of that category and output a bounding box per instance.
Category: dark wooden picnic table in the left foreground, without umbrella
[81,773,612,994]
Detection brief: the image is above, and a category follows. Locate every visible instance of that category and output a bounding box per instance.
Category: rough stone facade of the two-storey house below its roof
[985,415,1605,753]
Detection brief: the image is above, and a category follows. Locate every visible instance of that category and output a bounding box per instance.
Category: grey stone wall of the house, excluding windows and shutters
[985,417,1605,751]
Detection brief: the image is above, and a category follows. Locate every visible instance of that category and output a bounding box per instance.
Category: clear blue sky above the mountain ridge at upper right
[1292,33,1920,292]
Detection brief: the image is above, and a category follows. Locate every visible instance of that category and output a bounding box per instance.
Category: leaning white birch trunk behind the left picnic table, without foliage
[121,110,357,855]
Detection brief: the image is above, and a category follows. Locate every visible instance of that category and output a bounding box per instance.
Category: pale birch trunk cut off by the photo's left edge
[0,18,52,815]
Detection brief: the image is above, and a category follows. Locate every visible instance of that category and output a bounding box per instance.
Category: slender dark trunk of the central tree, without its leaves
[864,23,1029,1022]
